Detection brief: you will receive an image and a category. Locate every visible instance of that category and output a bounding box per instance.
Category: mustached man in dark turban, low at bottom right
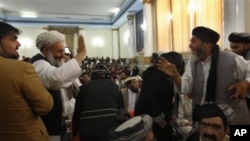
[186,104,234,141]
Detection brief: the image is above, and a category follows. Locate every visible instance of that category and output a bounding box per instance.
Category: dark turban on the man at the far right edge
[228,32,250,43]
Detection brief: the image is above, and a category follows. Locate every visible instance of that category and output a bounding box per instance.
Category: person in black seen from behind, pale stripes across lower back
[72,63,124,141]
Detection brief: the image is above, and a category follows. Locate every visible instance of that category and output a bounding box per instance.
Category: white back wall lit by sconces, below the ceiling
[16,26,113,59]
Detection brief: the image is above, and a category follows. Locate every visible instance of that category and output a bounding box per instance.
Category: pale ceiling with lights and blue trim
[0,0,142,27]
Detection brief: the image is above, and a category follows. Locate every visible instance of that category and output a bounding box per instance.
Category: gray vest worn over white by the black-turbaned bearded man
[191,52,250,124]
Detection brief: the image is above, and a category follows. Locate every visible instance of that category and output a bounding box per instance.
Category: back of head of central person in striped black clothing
[91,63,111,79]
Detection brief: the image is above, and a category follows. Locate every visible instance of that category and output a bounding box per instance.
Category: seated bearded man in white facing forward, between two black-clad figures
[121,76,140,117]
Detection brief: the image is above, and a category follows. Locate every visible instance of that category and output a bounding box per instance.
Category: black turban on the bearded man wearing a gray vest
[192,26,220,43]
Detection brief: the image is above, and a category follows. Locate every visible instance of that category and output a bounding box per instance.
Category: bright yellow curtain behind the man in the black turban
[154,0,223,53]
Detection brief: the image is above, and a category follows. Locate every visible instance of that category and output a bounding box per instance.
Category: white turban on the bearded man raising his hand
[36,30,66,50]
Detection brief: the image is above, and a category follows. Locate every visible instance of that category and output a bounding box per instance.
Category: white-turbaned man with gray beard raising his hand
[31,31,86,141]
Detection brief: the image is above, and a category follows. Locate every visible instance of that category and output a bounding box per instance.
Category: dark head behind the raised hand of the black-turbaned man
[160,51,185,75]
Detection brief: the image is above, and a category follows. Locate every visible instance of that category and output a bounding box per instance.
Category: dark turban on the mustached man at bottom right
[193,104,235,127]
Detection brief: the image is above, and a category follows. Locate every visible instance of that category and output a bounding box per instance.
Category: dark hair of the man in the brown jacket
[0,22,20,39]
